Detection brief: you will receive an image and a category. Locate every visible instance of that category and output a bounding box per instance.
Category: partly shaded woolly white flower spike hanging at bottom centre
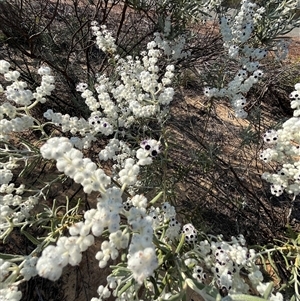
[87,195,162,301]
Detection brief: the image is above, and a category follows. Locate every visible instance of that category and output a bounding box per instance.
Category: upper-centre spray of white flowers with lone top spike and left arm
[44,22,175,155]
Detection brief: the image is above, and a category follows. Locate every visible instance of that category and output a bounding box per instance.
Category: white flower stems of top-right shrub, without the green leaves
[204,0,267,118]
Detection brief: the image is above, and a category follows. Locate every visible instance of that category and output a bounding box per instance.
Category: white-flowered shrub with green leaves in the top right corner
[204,0,297,118]
